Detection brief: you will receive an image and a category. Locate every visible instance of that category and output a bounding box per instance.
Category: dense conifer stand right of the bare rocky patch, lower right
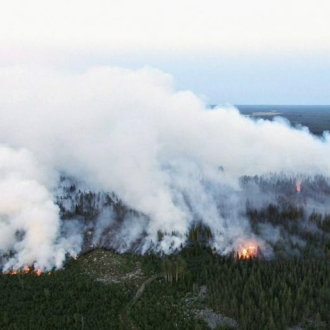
[184,248,330,330]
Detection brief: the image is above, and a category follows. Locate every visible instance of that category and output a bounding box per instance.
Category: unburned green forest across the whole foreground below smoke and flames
[0,244,330,330]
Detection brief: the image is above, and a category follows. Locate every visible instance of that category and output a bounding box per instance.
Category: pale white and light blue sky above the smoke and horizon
[0,0,330,104]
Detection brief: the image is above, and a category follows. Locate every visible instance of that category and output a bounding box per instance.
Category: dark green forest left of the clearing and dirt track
[0,262,134,330]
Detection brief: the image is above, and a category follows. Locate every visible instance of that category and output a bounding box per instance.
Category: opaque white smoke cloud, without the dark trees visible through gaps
[0,67,330,270]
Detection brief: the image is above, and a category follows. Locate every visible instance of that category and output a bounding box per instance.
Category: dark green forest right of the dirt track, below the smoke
[131,245,330,330]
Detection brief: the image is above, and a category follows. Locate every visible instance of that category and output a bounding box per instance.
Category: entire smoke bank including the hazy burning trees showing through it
[0,67,330,271]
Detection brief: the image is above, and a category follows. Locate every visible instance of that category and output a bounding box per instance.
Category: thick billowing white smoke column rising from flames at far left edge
[0,145,80,271]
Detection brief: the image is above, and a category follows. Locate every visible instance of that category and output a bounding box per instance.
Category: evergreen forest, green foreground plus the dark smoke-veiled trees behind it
[0,175,330,330]
